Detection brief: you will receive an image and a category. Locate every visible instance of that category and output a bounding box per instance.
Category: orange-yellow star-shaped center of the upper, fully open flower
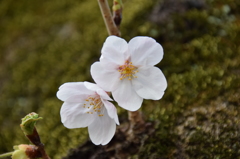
[118,60,138,80]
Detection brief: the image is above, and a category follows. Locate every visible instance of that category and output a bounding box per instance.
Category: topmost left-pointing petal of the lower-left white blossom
[57,82,94,102]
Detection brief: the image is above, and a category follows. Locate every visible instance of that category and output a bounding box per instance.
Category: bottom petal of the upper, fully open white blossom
[112,79,143,111]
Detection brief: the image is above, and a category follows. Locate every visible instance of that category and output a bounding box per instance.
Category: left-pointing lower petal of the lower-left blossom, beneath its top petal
[60,102,95,129]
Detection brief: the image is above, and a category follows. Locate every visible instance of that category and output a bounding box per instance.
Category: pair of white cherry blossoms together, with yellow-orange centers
[57,36,167,145]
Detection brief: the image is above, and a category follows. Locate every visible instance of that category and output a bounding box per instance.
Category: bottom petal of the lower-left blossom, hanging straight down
[88,110,116,145]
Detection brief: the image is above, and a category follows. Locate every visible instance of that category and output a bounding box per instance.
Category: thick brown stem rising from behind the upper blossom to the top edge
[98,0,120,36]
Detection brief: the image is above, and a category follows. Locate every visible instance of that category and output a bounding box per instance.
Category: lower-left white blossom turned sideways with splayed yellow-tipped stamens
[57,82,119,145]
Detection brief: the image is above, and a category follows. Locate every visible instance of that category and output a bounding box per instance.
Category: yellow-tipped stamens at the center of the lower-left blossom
[83,96,104,117]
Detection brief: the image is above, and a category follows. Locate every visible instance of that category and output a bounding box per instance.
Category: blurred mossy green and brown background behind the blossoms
[0,0,240,159]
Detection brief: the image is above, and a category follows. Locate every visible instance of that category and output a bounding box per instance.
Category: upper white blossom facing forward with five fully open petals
[91,36,167,111]
